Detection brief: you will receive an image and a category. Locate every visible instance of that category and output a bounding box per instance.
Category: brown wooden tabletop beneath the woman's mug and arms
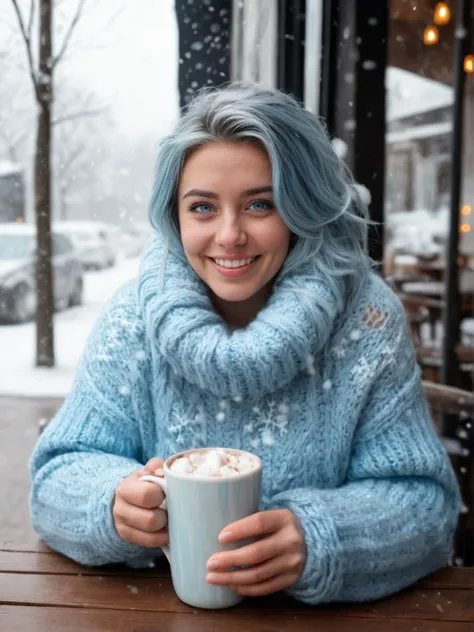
[0,543,474,632]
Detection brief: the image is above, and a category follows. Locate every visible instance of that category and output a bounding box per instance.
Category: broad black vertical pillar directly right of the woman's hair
[321,0,388,262]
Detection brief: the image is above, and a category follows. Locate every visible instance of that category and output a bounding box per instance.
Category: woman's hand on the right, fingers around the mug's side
[206,509,306,597]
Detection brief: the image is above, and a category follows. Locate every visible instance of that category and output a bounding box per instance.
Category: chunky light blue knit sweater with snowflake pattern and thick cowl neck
[31,242,460,604]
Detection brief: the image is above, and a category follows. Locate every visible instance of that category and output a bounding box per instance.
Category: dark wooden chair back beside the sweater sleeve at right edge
[423,381,474,566]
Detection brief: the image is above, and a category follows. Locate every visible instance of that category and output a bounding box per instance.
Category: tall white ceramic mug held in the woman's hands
[141,448,262,608]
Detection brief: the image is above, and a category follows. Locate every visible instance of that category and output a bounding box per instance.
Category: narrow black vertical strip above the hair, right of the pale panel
[277,0,306,102]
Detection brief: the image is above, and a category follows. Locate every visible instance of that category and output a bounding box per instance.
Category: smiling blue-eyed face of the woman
[178,142,290,322]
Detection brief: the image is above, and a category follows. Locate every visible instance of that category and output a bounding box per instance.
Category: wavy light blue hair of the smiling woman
[149,82,372,306]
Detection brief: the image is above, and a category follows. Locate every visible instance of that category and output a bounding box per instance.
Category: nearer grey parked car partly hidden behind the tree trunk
[0,223,84,323]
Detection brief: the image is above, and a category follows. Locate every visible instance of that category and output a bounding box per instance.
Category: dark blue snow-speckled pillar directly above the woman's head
[175,0,232,107]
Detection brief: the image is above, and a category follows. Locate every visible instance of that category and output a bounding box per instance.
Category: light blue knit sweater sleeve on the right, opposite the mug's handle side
[270,298,460,604]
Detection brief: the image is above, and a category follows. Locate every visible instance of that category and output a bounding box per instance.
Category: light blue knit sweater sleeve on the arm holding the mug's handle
[30,287,160,566]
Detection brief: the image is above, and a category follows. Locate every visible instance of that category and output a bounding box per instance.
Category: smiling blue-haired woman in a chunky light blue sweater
[31,84,459,604]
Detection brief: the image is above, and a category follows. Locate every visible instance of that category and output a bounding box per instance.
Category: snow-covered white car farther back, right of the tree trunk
[54,220,117,270]
